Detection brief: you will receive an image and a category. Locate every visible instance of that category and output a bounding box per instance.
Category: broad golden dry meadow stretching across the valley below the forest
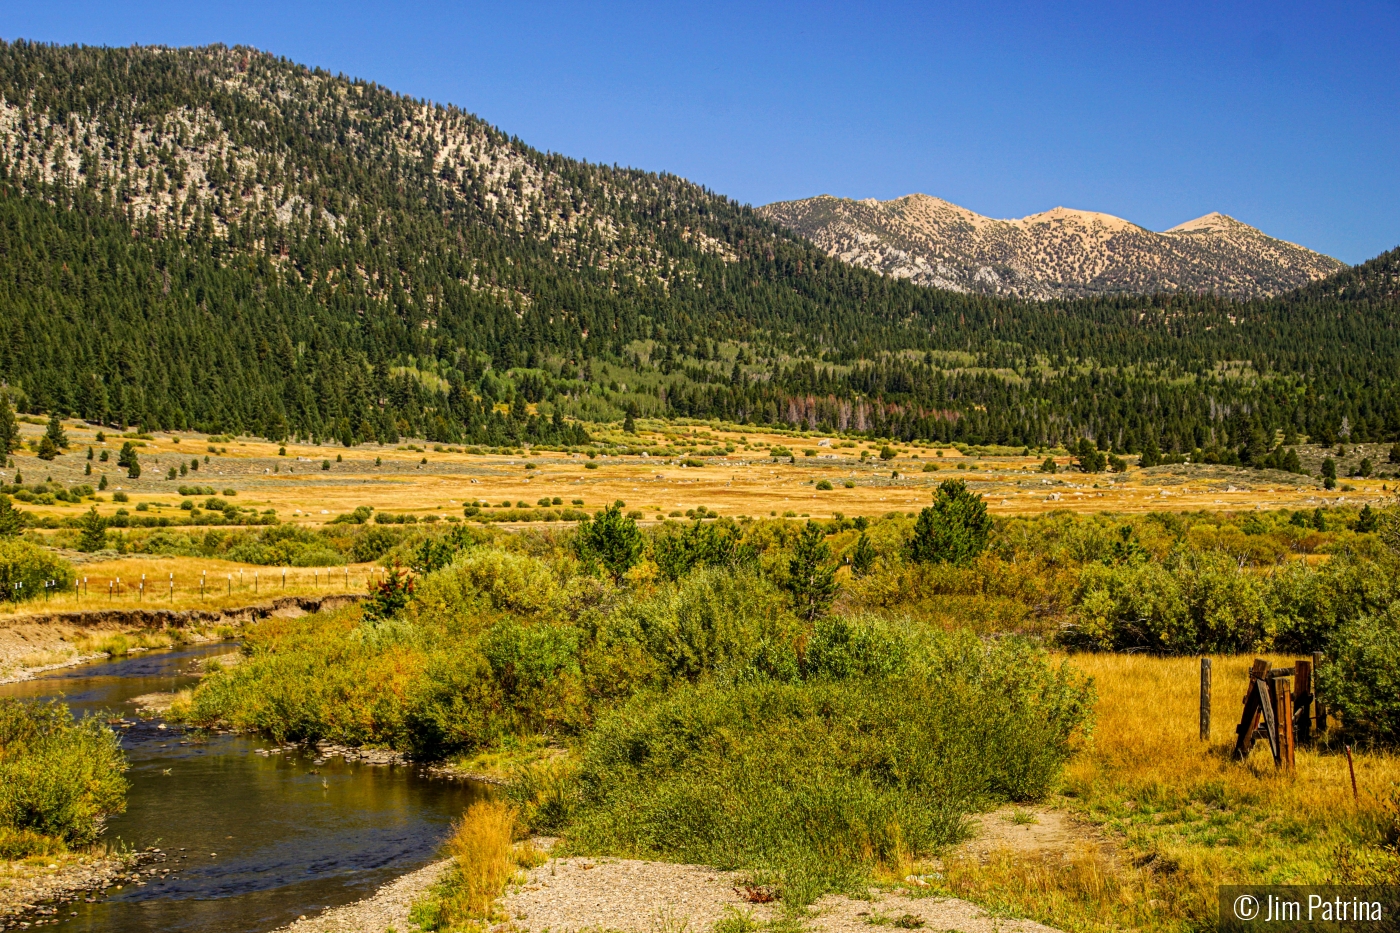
[15,422,1385,532]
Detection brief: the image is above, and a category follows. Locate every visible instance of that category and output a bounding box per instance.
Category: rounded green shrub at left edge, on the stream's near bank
[0,699,126,840]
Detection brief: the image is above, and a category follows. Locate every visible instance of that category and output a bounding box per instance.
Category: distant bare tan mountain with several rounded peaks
[759,195,1345,298]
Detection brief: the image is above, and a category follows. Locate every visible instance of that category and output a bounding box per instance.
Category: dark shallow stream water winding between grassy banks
[0,643,484,933]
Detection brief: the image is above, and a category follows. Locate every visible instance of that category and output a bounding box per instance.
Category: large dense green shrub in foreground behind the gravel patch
[570,637,1092,904]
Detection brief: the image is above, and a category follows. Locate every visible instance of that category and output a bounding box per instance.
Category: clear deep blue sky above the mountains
[0,0,1400,262]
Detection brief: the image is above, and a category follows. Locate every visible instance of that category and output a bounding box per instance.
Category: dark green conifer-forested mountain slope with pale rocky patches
[0,42,1400,450]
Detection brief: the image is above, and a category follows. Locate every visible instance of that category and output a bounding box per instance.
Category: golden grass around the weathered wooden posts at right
[948,654,1400,930]
